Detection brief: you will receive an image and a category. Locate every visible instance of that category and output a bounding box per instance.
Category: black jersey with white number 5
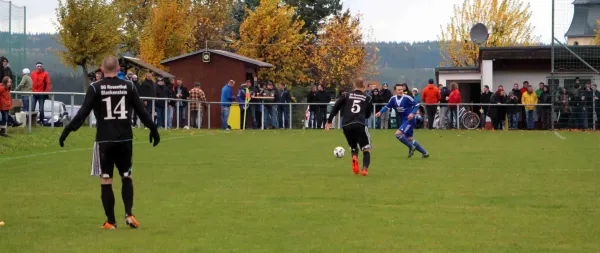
[327,90,373,127]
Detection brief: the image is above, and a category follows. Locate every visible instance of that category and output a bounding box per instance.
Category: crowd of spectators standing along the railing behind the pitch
[0,52,600,133]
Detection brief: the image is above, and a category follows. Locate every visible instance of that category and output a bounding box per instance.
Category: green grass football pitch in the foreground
[0,128,600,253]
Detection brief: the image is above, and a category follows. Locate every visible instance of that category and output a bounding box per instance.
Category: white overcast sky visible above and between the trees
[5,0,573,43]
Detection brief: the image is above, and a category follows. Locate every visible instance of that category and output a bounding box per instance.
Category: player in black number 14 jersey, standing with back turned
[59,56,160,229]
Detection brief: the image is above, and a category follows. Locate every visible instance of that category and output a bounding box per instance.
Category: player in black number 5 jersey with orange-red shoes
[325,79,373,176]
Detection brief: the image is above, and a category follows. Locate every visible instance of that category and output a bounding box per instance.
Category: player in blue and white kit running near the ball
[375,85,429,158]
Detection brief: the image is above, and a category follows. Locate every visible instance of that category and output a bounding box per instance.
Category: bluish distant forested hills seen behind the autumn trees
[0,34,442,100]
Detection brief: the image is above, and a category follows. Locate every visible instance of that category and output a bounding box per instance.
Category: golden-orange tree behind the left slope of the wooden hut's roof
[139,0,194,69]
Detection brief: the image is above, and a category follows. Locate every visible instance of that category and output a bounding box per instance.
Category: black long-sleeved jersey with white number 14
[66,77,156,142]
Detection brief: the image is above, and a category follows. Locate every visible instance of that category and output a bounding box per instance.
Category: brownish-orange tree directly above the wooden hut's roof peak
[192,0,234,50]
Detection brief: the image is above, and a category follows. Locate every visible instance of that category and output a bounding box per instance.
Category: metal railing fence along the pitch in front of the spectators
[11,92,600,132]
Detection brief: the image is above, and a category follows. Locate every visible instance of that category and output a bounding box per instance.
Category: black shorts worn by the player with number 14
[92,141,133,178]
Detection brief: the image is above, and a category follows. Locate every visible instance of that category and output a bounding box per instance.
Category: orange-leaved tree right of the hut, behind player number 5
[311,10,378,85]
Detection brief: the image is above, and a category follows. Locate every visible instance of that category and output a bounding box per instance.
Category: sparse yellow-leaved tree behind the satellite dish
[440,0,539,67]
